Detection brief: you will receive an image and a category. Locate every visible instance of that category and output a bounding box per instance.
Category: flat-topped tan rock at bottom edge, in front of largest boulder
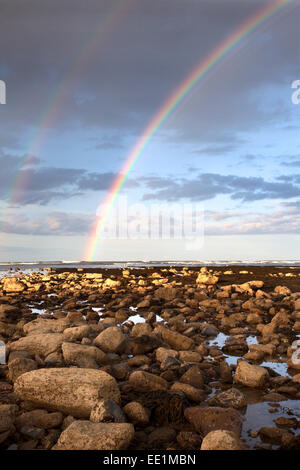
[52,421,134,450]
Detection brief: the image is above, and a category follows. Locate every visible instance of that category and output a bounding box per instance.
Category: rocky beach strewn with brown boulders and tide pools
[0,266,300,451]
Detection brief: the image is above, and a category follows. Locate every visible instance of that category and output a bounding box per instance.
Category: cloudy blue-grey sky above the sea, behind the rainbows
[0,0,300,261]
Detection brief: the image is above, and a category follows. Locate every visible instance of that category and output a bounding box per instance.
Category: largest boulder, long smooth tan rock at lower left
[15,367,120,418]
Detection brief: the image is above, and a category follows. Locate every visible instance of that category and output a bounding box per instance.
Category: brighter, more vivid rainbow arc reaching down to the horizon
[83,0,295,261]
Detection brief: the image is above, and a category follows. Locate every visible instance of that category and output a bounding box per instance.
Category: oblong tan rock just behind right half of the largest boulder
[62,343,106,369]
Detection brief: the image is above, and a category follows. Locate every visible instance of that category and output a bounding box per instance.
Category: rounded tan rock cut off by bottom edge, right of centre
[201,430,247,450]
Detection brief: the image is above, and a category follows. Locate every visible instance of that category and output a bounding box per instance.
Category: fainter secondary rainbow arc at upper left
[2,0,136,209]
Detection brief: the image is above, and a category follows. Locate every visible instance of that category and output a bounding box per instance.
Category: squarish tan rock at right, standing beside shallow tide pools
[234,361,269,388]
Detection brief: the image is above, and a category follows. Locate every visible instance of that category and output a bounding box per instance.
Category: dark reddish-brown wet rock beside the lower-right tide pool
[184,407,242,436]
